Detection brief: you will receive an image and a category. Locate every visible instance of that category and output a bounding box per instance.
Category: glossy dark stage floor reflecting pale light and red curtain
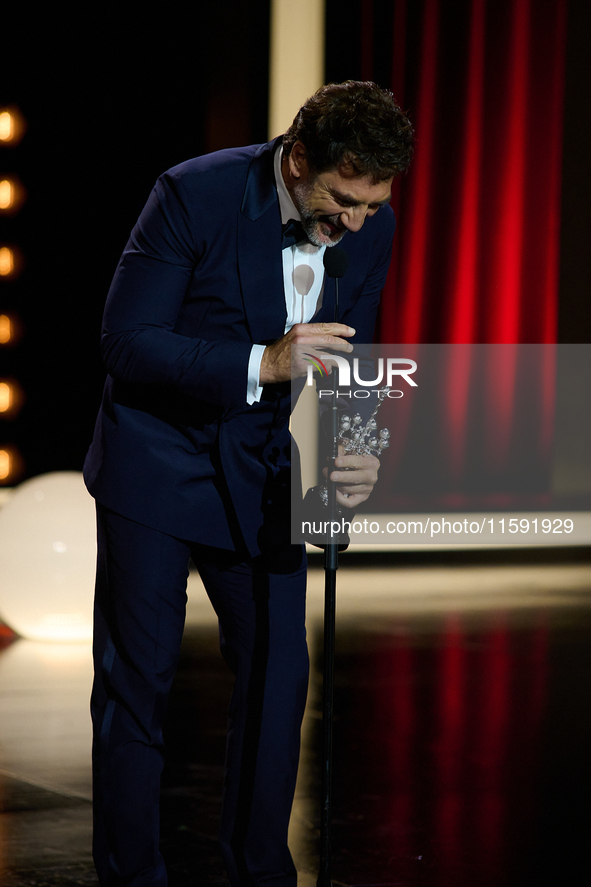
[0,562,591,887]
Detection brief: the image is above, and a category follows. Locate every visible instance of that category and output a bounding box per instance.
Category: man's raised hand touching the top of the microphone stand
[259,323,355,385]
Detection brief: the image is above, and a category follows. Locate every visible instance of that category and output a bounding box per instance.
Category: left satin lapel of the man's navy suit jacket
[238,139,286,344]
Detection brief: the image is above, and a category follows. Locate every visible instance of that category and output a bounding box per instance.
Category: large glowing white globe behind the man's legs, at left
[0,471,96,641]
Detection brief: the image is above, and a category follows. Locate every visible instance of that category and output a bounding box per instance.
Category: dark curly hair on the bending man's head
[283,80,414,184]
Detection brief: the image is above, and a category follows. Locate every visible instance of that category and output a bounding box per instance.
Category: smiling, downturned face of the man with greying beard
[289,142,392,246]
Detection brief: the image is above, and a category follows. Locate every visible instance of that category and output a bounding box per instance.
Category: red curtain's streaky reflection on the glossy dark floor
[360,609,549,887]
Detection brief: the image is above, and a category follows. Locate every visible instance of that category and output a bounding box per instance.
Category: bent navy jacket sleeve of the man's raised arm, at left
[101,172,251,406]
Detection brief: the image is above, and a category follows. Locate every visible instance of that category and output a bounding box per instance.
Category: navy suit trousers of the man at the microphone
[91,505,308,887]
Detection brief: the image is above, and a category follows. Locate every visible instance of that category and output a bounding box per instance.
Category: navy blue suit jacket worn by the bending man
[84,140,394,555]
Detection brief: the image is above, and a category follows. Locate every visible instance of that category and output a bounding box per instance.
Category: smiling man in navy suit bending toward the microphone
[85,81,412,887]
